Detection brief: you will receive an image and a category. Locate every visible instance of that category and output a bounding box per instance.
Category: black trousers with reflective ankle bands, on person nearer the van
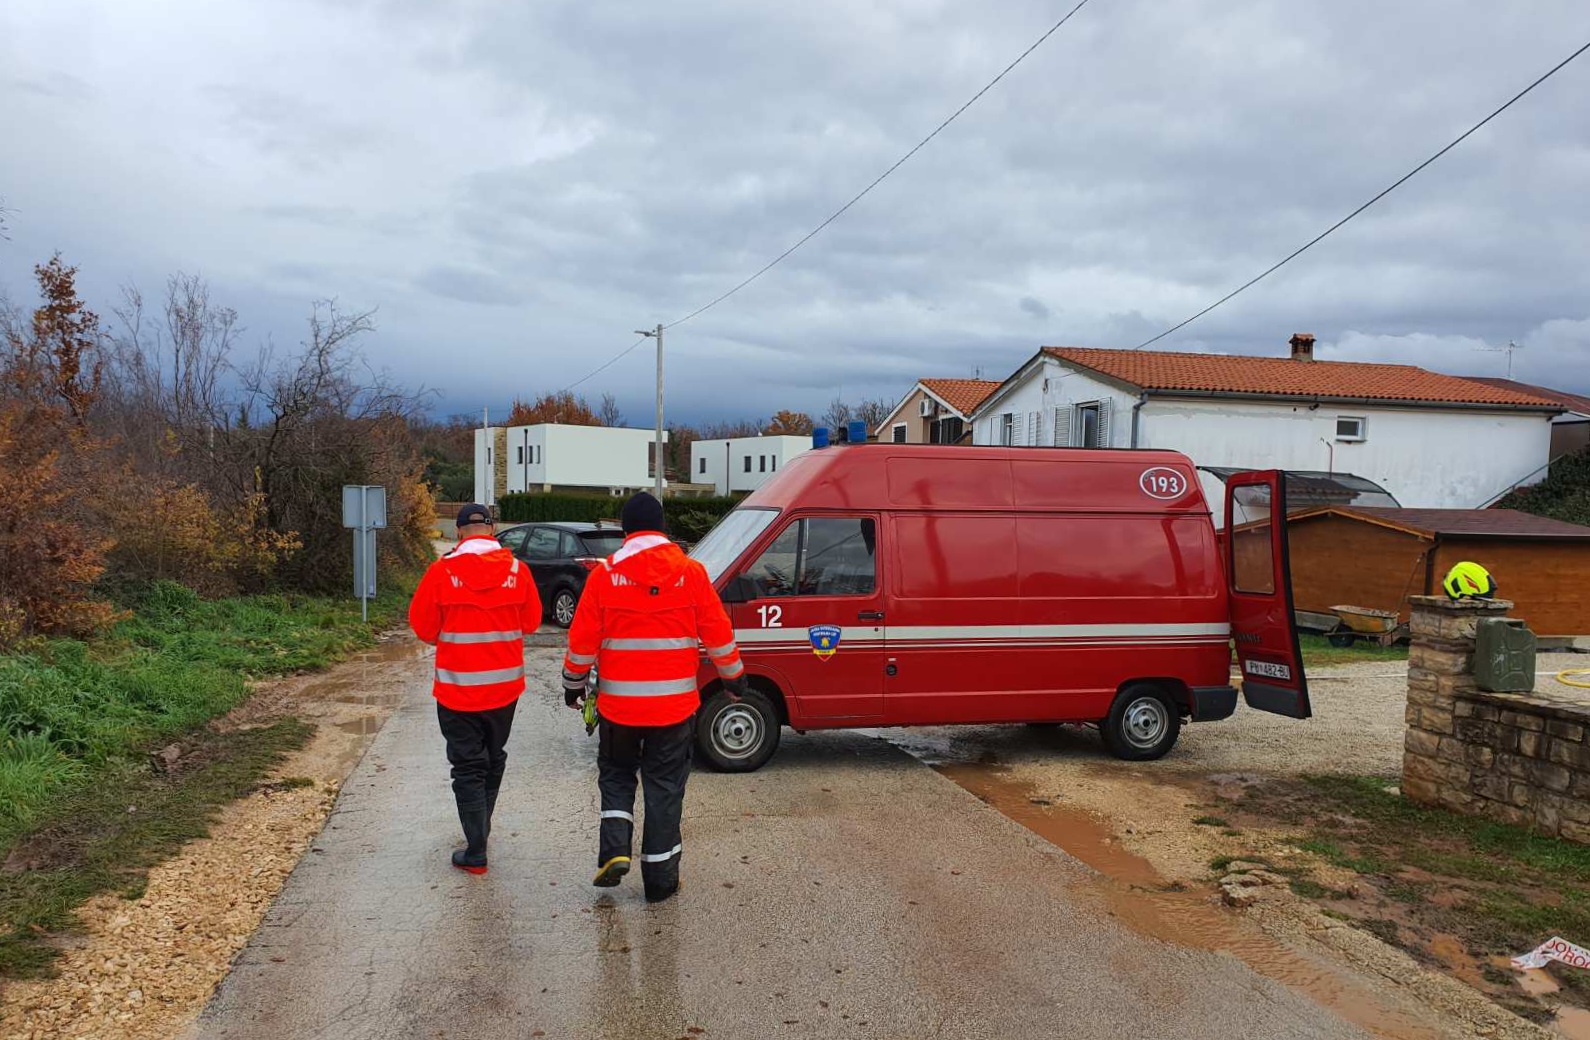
[596,716,695,884]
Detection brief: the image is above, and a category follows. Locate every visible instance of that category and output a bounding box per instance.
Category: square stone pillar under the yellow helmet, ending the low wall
[1402,596,1512,813]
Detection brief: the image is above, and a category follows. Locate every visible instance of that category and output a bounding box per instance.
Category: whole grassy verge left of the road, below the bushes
[0,582,409,978]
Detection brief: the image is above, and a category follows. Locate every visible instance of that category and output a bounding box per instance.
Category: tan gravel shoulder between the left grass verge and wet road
[0,636,425,1040]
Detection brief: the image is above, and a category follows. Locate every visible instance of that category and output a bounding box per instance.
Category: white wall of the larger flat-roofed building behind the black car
[499,423,668,491]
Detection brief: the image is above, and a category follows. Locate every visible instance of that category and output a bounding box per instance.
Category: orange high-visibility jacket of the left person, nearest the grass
[409,537,541,711]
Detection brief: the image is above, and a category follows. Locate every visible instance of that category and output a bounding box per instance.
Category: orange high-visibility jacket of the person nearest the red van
[563,533,746,725]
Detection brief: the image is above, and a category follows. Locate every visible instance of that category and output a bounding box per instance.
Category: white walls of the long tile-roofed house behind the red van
[973,358,1552,509]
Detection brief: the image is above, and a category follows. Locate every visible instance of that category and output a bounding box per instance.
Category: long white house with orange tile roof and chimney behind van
[971,334,1563,509]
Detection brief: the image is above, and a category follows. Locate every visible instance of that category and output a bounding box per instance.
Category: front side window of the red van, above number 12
[746,517,878,598]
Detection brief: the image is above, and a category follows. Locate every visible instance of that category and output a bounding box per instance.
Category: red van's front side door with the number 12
[731,514,884,722]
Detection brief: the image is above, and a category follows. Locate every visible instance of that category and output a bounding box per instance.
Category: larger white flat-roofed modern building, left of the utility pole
[475,423,668,504]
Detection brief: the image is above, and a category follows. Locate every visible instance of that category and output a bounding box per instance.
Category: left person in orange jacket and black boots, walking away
[409,504,541,875]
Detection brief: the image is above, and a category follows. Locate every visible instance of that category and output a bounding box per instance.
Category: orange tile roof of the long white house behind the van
[1043,347,1555,409]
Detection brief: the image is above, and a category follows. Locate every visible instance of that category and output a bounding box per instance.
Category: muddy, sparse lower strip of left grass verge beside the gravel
[0,719,310,978]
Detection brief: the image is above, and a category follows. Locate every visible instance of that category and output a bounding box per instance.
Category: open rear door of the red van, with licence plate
[1223,469,1313,719]
